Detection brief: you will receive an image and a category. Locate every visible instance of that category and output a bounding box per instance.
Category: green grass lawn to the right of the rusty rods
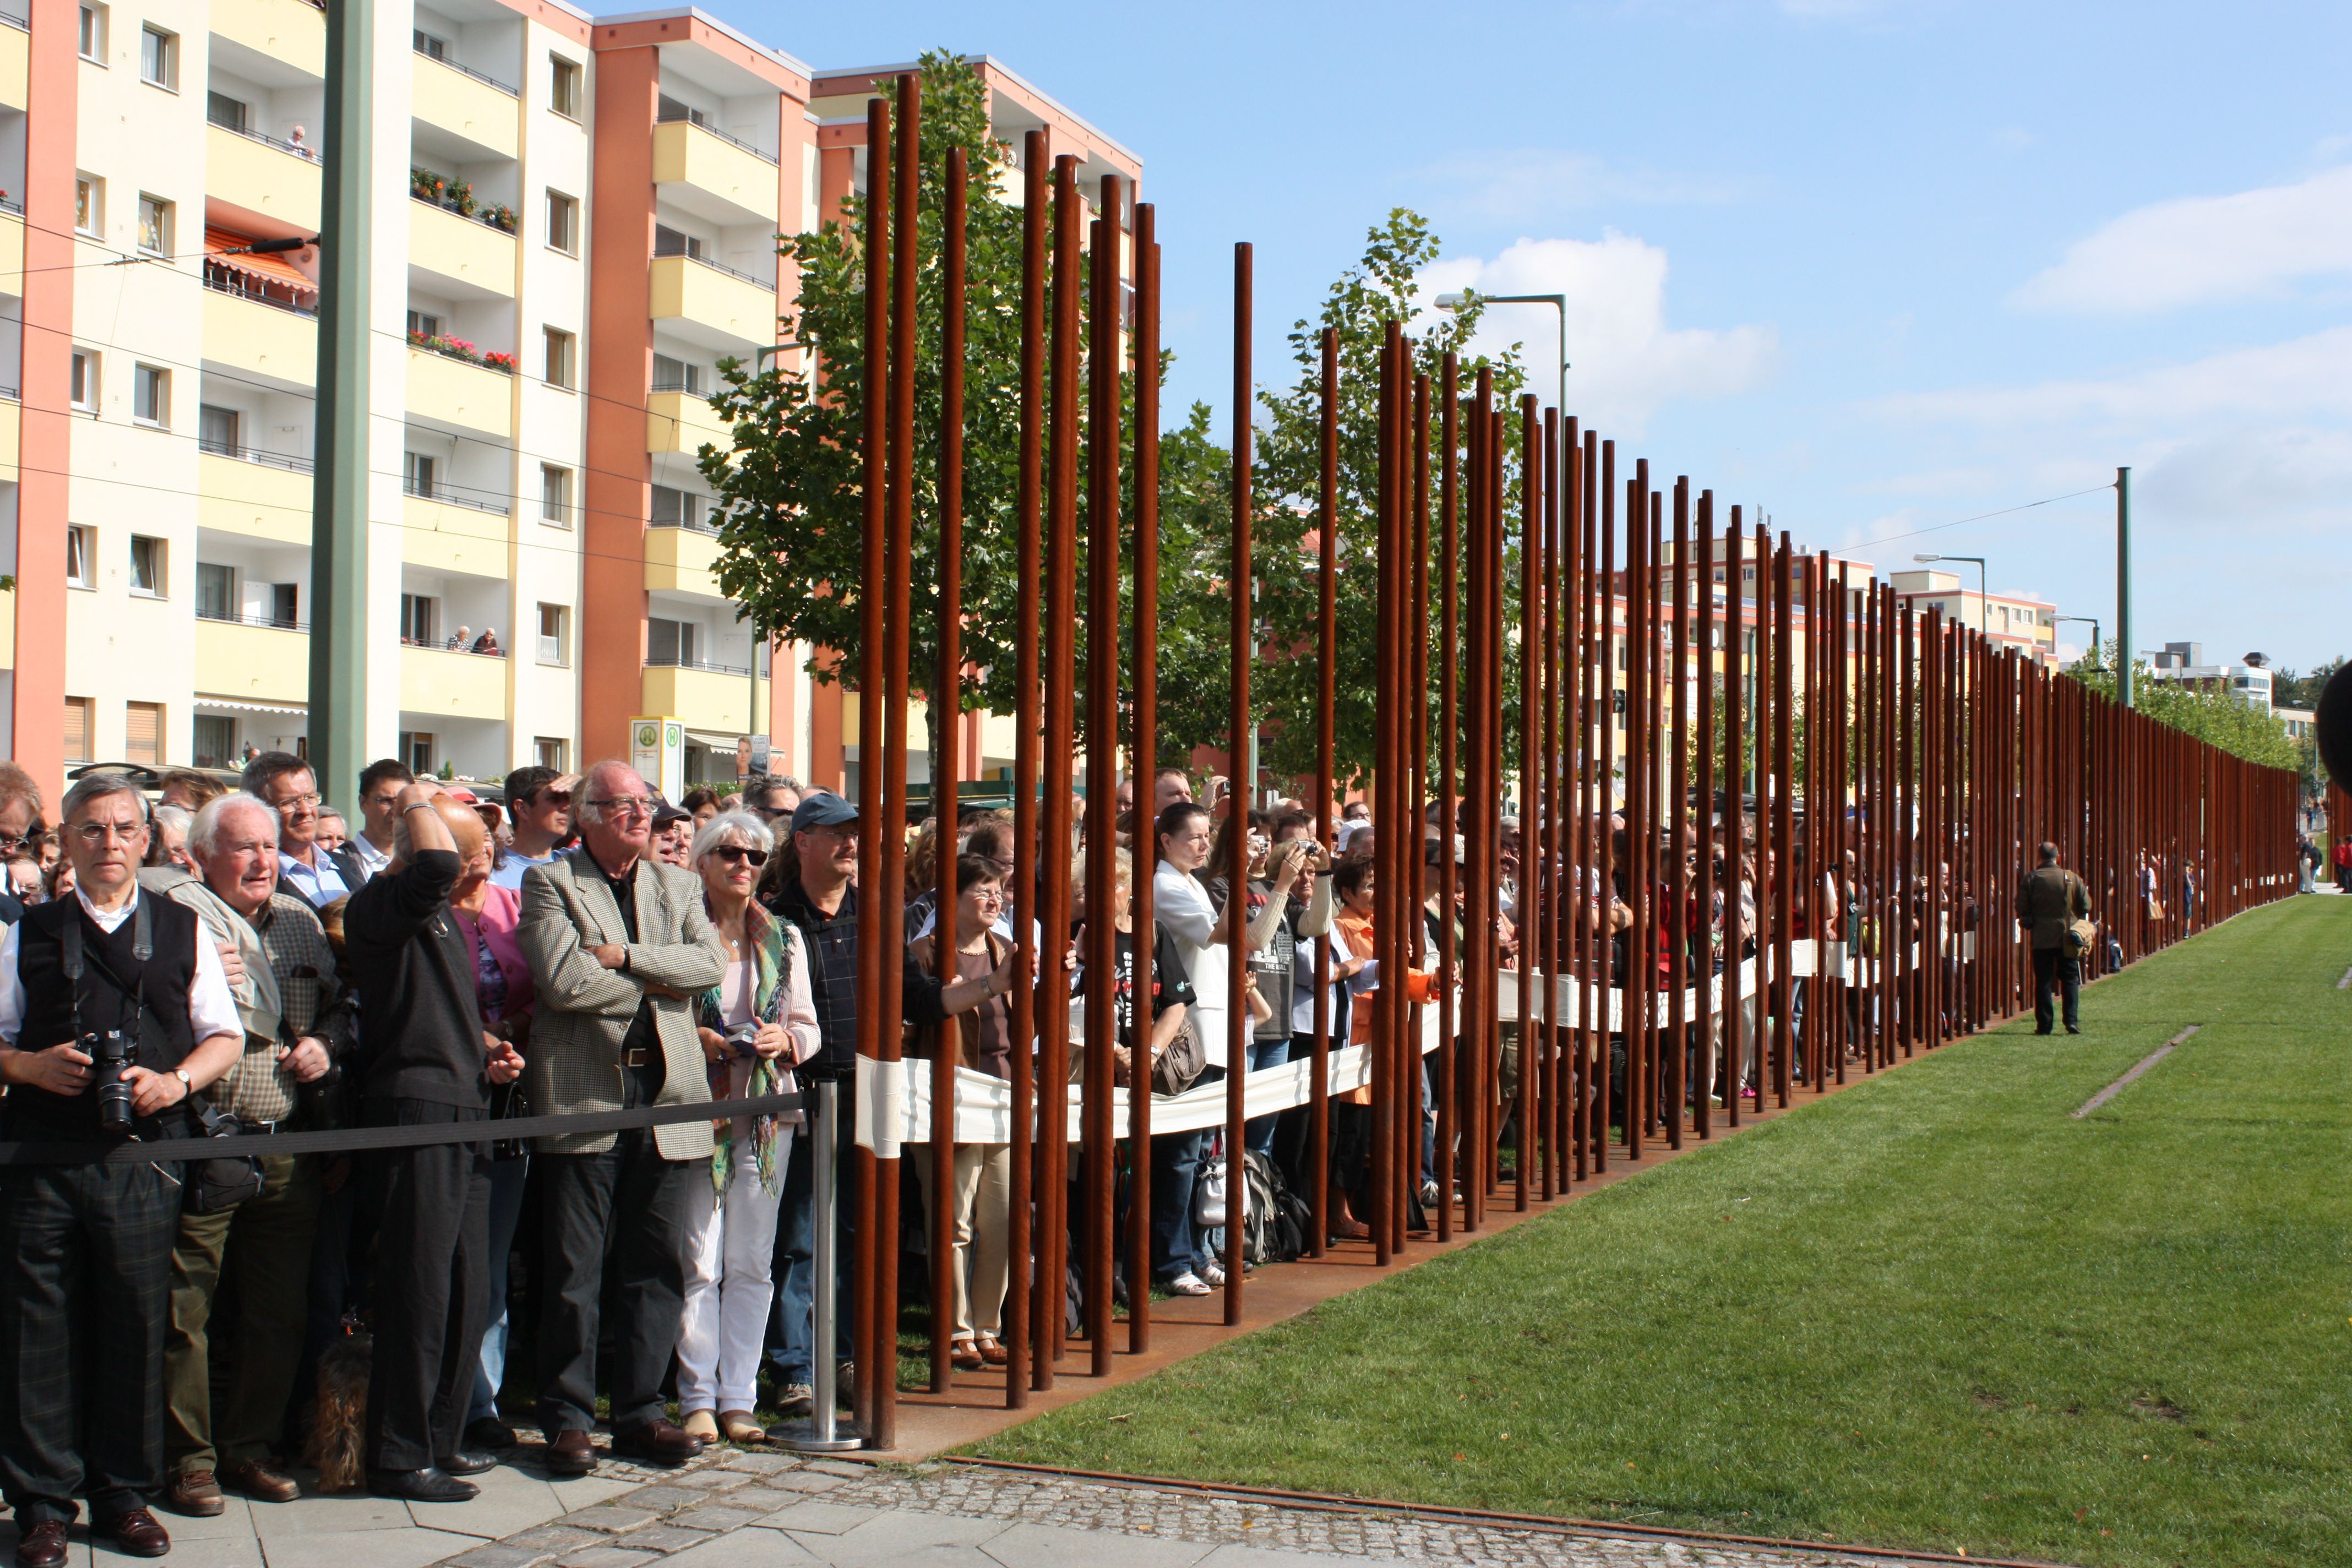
[971,898,2352,1568]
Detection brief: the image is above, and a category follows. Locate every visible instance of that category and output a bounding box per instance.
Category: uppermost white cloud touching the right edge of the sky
[2011,165,2352,315]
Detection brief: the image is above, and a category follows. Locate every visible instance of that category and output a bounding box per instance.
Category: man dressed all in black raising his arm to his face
[344,783,522,1502]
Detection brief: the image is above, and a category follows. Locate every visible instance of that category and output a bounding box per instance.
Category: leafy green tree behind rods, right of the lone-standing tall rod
[1251,207,1524,785]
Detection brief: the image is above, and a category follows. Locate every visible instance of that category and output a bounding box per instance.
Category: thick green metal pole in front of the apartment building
[308,0,377,820]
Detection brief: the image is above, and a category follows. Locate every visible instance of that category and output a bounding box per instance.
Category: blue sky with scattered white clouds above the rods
[706,0,2352,668]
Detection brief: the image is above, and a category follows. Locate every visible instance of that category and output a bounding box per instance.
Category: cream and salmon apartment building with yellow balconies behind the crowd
[0,0,1139,792]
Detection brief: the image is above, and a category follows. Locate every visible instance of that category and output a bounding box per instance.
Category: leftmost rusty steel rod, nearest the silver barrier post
[846,94,896,1429]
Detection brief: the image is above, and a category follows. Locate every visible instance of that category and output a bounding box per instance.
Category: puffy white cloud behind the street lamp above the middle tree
[1420,230,1778,437]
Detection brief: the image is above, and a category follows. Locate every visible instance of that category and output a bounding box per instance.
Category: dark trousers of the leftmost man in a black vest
[0,1164,179,1531]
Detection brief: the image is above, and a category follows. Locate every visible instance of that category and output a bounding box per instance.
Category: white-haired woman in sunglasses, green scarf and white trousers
[677,811,821,1444]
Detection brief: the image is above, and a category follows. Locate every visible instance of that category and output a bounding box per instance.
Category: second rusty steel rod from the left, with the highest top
[858,73,922,1451]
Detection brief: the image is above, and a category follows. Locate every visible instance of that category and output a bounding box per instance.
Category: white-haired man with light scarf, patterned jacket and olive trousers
[139,792,357,1516]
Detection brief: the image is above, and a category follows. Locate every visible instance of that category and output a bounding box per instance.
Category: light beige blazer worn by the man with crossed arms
[515,848,727,1159]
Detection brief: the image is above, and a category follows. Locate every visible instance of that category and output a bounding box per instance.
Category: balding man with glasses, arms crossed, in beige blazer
[520,761,727,1476]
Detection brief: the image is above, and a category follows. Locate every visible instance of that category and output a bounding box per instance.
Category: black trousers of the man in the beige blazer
[531,1126,696,1439]
